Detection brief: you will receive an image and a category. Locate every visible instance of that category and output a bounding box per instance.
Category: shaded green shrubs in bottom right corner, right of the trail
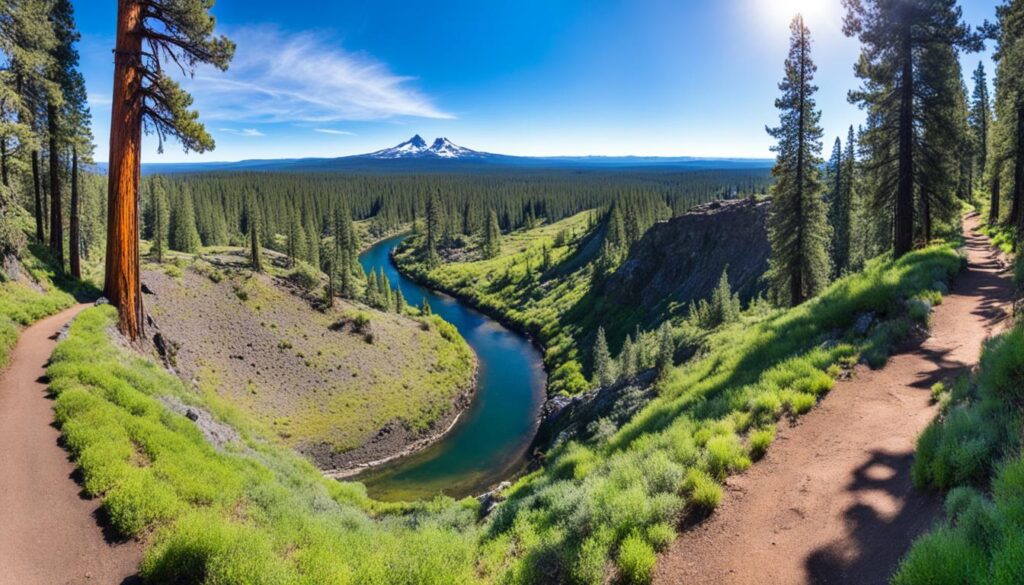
[892,325,1024,585]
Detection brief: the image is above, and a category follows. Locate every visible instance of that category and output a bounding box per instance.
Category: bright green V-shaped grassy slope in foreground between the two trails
[50,221,962,584]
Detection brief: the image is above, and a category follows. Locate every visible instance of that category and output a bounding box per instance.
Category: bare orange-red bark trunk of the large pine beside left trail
[103,0,144,340]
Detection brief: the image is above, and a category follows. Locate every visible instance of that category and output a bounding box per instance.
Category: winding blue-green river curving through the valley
[352,236,546,501]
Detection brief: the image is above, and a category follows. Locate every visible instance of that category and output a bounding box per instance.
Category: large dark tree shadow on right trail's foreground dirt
[805,450,942,585]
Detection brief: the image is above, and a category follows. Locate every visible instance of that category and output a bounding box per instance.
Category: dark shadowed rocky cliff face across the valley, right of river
[604,199,771,322]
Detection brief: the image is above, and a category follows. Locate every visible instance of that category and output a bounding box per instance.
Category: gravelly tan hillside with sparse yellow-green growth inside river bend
[142,252,475,470]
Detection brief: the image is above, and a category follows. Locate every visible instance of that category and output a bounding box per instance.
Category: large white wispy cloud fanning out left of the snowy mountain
[187,27,453,124]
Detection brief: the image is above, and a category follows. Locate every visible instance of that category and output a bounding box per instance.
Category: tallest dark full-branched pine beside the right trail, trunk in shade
[843,0,980,257]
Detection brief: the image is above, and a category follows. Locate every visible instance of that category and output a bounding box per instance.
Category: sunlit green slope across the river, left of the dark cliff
[395,212,591,394]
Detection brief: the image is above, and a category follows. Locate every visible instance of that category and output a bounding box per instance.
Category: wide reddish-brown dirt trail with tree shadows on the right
[654,217,1011,585]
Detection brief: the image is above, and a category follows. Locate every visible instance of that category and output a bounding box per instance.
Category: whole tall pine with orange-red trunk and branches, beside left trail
[103,0,234,339]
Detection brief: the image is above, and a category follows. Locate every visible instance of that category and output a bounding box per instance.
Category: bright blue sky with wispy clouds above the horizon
[75,0,996,162]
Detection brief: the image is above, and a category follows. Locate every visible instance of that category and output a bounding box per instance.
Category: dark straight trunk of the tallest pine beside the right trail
[893,26,913,258]
